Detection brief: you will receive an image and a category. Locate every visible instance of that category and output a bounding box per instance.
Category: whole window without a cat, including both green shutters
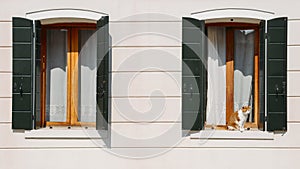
[12,16,110,130]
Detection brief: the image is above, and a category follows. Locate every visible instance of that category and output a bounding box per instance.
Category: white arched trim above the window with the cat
[190,8,275,20]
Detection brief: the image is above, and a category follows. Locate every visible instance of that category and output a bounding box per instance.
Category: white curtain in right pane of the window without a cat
[78,30,97,122]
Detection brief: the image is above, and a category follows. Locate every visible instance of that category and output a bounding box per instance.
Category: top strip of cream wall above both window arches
[0,0,299,21]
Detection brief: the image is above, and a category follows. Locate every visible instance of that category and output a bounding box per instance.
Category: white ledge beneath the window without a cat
[25,128,101,139]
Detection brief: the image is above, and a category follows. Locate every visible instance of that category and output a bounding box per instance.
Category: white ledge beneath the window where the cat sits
[190,130,274,140]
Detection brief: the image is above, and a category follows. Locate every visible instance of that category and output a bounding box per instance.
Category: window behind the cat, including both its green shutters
[182,18,287,131]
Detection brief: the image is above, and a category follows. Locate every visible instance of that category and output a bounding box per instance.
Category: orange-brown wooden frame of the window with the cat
[205,22,260,130]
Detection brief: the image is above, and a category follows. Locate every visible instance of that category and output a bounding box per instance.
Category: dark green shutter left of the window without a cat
[12,18,34,130]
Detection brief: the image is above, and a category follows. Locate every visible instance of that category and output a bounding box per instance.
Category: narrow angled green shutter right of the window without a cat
[96,16,110,139]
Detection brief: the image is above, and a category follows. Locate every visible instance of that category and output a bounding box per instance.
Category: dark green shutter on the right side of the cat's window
[267,17,287,131]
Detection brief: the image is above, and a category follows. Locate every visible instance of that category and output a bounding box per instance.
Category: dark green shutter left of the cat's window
[182,17,207,130]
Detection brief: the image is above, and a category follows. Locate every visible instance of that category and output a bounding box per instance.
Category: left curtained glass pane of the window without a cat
[46,29,67,122]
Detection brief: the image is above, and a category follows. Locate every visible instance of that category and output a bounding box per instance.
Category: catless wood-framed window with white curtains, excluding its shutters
[41,23,97,126]
